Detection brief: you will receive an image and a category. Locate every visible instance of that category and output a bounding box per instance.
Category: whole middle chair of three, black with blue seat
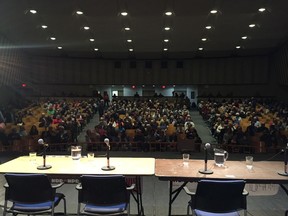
[76,175,135,216]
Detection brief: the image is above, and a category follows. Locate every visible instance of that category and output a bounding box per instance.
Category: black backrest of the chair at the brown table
[191,180,246,213]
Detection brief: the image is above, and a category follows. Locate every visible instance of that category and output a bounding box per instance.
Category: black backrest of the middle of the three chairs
[78,175,129,205]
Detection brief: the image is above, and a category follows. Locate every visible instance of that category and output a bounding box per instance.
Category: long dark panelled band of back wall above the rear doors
[31,57,269,85]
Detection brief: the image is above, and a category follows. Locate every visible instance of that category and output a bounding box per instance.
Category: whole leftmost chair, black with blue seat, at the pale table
[3,174,66,216]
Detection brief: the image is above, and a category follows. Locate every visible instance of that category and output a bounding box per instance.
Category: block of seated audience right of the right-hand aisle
[198,98,288,151]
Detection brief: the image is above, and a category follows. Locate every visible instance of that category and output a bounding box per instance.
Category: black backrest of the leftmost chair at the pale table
[4,174,55,203]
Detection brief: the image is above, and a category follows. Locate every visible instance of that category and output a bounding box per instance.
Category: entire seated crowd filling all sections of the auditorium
[0,94,288,154]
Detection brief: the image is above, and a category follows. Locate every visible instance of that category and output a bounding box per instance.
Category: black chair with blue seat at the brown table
[184,180,248,216]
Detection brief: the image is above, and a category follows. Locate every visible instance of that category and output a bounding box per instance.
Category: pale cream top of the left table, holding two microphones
[0,155,155,176]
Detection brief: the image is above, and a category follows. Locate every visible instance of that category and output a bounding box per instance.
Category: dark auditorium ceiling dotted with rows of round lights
[0,0,288,59]
